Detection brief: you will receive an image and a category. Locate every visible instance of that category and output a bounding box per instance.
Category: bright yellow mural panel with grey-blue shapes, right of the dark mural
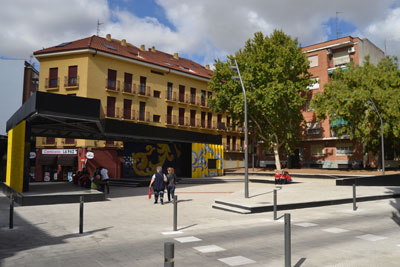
[192,143,224,178]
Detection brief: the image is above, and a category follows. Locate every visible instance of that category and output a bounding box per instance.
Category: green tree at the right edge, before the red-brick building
[311,57,400,165]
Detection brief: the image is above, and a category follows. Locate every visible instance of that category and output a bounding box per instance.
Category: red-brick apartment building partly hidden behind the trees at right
[300,36,384,168]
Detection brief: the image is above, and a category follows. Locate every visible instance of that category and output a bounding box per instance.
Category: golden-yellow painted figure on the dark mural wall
[132,144,180,176]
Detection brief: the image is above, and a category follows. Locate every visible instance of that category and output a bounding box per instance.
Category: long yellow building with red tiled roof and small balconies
[34,34,244,180]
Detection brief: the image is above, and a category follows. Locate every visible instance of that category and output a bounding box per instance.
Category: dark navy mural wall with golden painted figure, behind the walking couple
[123,142,182,178]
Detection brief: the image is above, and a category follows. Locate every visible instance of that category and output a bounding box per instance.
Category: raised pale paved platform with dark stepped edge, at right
[213,176,400,214]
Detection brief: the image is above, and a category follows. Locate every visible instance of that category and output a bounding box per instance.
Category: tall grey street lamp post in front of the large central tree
[229,59,249,198]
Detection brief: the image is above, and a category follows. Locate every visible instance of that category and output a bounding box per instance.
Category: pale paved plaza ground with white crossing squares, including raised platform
[0,176,400,267]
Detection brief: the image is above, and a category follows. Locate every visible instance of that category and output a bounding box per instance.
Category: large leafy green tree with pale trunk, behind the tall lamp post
[209,30,311,170]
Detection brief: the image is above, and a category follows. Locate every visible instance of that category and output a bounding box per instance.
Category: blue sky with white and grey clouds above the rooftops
[0,0,400,134]
